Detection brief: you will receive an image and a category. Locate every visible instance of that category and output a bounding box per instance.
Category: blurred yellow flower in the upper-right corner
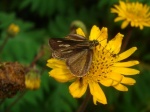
[111,1,150,30]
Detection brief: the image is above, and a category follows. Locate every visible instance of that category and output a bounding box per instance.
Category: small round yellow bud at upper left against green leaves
[7,23,20,37]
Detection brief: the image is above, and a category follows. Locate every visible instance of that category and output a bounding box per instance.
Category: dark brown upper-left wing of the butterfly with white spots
[49,38,89,59]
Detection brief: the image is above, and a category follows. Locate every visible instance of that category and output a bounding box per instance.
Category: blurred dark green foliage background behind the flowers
[0,0,150,112]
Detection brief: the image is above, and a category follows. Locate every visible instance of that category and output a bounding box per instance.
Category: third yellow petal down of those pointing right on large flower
[111,67,140,75]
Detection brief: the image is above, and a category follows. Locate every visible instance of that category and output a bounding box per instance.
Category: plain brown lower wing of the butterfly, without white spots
[66,49,93,77]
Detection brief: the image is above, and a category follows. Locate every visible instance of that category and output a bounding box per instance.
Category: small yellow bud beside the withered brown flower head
[25,71,41,90]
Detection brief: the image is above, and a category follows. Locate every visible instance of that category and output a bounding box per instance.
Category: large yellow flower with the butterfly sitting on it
[47,25,139,104]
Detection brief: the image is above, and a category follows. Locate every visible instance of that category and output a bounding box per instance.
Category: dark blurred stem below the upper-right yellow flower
[121,28,132,51]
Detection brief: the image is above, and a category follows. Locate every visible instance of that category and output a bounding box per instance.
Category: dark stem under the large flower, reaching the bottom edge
[77,89,91,112]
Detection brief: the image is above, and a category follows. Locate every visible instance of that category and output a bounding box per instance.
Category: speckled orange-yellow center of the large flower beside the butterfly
[85,46,116,82]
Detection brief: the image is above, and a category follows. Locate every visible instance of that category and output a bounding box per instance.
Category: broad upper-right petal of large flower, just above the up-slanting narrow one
[106,33,123,54]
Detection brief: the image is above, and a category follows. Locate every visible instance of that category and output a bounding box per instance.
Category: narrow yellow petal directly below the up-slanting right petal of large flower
[113,61,139,67]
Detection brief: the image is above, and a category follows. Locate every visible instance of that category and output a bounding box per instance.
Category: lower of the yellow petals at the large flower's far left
[49,68,75,82]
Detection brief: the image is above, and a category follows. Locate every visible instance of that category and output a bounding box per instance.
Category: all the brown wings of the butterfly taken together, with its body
[49,34,93,77]
